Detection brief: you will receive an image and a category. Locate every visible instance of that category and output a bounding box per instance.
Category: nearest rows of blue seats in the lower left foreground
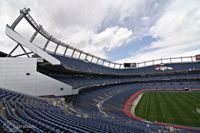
[0,89,144,133]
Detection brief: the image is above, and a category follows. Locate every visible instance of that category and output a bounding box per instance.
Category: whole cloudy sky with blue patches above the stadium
[0,0,200,62]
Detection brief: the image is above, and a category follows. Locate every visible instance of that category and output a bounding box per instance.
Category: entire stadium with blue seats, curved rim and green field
[0,8,200,133]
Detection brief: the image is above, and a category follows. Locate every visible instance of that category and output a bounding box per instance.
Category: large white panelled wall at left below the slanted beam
[0,58,77,96]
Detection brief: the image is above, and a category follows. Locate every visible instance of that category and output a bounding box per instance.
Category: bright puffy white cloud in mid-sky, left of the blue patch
[60,26,133,57]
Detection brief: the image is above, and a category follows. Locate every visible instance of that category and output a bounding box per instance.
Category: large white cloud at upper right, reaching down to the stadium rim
[121,0,200,62]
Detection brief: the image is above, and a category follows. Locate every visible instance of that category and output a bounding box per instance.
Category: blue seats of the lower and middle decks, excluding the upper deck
[0,66,200,133]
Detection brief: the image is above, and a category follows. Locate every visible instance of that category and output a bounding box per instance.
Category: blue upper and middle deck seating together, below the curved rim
[38,54,200,89]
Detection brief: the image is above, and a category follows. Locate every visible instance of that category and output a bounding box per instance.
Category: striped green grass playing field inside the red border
[135,92,200,127]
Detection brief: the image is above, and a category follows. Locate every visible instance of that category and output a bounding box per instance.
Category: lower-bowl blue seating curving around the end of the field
[73,82,200,132]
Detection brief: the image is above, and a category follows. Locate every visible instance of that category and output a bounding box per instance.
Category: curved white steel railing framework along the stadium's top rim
[7,8,196,69]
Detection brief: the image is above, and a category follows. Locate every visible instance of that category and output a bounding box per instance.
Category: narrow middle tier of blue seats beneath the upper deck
[40,71,200,89]
